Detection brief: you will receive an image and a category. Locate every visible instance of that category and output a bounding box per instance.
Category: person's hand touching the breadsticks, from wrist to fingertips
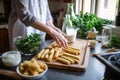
[50,29,68,48]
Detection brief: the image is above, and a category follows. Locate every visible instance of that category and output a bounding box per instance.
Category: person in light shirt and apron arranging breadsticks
[8,0,68,49]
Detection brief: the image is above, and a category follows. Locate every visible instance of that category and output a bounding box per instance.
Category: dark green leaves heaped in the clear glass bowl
[15,34,42,54]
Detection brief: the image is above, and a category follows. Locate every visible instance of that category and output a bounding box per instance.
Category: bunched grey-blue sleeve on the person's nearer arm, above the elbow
[14,0,38,26]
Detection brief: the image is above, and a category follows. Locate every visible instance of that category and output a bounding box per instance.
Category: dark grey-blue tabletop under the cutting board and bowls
[0,40,105,80]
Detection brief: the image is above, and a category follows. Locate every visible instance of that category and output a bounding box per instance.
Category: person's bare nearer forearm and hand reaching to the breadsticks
[32,21,68,48]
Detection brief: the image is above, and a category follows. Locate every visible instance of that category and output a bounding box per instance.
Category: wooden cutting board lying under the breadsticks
[34,39,90,71]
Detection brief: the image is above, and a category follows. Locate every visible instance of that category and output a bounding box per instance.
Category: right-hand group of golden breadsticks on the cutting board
[57,46,80,65]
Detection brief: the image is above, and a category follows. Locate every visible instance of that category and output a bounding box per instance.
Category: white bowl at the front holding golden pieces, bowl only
[16,63,48,80]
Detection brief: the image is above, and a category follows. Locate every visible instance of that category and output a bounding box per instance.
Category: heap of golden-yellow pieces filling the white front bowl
[19,59,46,76]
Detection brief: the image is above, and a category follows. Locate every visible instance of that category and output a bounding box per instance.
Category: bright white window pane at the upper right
[96,0,117,21]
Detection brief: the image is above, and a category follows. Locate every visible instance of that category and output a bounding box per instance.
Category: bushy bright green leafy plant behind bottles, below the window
[71,11,110,38]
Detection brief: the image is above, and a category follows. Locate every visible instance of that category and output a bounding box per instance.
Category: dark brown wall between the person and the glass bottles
[49,1,67,29]
